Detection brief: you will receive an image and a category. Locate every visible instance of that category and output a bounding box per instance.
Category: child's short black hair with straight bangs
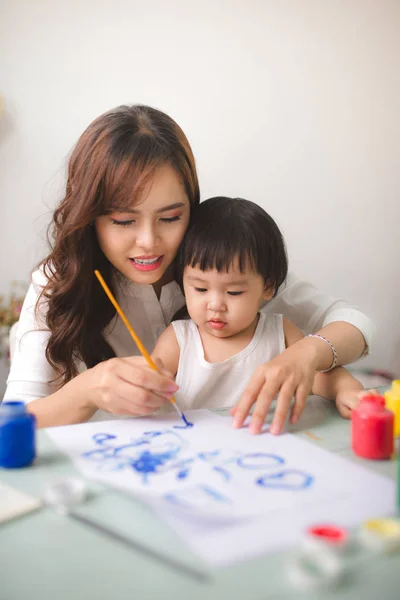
[178,196,288,295]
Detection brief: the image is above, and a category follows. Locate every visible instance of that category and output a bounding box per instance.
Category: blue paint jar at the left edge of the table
[0,402,36,469]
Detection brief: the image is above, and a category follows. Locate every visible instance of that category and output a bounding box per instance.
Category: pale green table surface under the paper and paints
[0,396,400,600]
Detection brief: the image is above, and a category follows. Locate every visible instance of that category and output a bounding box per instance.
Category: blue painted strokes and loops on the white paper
[82,426,314,506]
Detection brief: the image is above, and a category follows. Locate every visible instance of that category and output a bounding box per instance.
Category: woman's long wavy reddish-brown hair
[36,105,199,383]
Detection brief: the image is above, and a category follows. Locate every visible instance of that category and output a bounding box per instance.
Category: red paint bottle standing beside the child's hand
[351,394,394,459]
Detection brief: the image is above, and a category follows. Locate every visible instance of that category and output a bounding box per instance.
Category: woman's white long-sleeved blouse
[4,270,374,402]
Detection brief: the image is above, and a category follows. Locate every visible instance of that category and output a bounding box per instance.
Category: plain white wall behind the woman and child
[0,0,400,394]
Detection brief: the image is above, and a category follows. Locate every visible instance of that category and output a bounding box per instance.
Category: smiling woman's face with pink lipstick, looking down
[95,165,190,285]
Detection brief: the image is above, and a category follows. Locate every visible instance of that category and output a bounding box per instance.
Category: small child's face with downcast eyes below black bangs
[183,264,273,338]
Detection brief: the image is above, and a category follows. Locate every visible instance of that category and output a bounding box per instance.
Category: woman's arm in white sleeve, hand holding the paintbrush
[4,273,177,427]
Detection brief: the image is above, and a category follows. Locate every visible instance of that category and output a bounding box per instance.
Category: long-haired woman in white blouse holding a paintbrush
[5,106,373,431]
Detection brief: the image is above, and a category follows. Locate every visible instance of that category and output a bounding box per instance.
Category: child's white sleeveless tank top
[172,312,285,410]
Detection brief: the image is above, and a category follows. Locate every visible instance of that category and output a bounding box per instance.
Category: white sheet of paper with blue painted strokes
[47,410,395,565]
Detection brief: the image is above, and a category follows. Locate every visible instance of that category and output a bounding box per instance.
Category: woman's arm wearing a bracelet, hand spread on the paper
[233,275,374,433]
